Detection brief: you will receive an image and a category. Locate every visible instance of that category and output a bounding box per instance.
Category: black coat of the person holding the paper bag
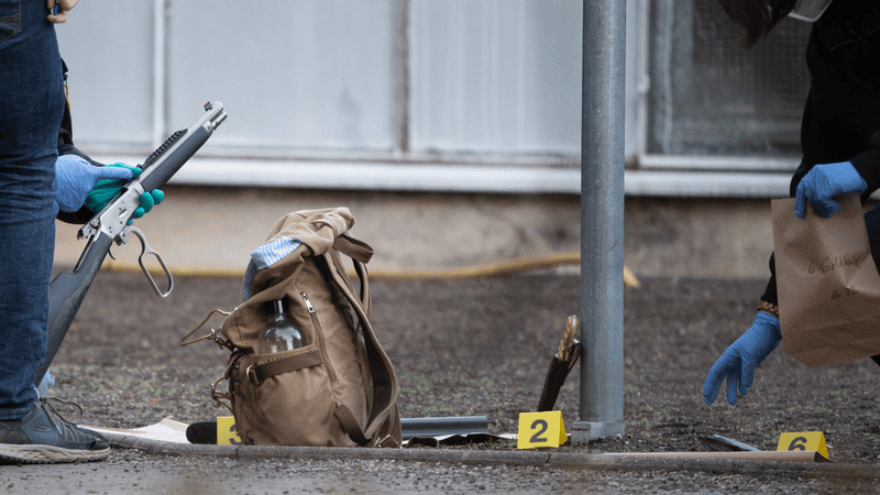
[761,0,880,305]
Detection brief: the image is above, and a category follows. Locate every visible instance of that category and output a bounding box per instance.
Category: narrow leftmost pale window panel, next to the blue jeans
[56,0,153,149]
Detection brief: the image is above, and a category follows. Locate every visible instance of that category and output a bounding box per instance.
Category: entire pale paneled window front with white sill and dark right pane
[58,0,809,196]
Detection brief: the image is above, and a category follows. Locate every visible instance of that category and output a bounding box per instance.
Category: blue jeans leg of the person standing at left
[0,0,65,420]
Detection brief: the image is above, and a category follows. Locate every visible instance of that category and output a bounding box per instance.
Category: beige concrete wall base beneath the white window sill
[55,186,772,277]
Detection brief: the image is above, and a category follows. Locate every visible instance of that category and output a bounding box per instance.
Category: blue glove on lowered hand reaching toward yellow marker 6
[703,311,782,406]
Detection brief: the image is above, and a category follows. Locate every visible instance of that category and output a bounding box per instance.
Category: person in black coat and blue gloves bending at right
[703,0,880,405]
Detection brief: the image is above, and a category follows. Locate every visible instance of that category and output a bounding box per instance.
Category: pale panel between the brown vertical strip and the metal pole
[409,0,583,154]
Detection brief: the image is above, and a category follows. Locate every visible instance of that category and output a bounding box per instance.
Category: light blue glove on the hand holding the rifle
[55,155,133,212]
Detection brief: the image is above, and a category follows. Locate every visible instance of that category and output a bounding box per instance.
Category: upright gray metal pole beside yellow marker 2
[572,0,627,444]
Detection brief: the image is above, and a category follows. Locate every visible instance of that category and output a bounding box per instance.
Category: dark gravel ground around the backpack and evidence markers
[0,272,880,494]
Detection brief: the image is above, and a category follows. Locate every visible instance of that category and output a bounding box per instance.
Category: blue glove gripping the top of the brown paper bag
[794,162,868,218]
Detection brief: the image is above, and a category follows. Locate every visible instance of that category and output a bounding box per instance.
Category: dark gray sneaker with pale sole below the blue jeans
[0,399,110,464]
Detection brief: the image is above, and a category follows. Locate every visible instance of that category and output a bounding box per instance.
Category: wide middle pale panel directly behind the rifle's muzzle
[168,0,396,151]
